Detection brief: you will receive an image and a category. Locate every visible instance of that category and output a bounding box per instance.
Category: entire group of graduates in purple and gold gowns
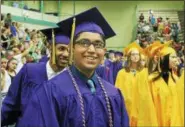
[1,7,184,127]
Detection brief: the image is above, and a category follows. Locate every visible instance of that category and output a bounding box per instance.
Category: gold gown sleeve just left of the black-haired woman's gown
[137,69,158,126]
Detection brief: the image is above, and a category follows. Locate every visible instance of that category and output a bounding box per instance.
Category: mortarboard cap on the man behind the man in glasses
[41,27,70,45]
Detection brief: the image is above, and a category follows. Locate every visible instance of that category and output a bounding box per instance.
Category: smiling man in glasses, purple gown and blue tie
[19,8,129,127]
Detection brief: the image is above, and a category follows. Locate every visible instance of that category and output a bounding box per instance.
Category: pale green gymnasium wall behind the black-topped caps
[1,1,184,51]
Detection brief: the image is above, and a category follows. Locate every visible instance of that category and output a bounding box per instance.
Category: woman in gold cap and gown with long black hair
[149,46,183,127]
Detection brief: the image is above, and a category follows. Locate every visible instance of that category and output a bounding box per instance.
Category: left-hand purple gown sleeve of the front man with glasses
[17,82,59,127]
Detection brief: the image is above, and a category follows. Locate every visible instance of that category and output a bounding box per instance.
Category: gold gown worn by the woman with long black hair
[149,72,182,127]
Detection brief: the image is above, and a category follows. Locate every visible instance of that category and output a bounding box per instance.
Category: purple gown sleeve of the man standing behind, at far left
[1,66,27,126]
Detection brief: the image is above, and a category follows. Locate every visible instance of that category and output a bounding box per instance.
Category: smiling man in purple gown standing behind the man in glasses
[1,28,70,126]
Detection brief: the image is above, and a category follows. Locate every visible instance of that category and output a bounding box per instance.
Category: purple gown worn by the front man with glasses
[19,66,129,127]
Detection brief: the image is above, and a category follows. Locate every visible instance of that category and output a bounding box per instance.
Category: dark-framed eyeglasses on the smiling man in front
[75,39,105,49]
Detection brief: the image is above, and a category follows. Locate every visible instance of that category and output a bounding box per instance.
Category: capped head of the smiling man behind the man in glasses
[38,28,70,70]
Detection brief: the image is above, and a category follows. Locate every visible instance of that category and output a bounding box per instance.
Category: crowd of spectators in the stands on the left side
[0,13,46,90]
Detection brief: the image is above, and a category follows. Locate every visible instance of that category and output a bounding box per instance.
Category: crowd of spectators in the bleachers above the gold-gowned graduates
[136,10,184,66]
